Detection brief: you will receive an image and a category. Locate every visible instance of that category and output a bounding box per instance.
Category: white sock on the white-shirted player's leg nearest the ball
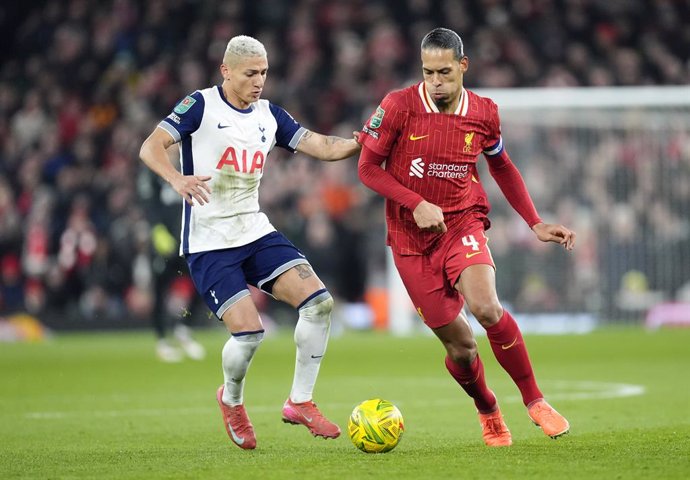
[290,289,333,403]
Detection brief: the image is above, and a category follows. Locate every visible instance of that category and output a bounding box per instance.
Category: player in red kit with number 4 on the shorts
[359,28,575,446]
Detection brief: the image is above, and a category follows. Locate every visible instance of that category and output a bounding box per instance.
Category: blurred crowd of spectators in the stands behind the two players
[0,0,690,335]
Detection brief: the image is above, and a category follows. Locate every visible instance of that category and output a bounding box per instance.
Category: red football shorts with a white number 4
[393,222,495,328]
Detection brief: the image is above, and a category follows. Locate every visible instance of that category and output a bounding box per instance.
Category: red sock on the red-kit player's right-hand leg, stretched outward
[486,310,543,405]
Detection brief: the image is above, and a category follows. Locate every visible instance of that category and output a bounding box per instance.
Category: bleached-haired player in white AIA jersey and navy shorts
[140,35,359,449]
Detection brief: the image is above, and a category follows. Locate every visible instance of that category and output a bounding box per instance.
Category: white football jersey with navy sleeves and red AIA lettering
[158,86,306,255]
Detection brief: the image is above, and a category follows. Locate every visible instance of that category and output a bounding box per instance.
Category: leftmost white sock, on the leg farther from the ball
[222,330,264,406]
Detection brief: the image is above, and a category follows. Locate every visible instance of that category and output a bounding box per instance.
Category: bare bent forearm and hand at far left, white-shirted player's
[139,128,211,205]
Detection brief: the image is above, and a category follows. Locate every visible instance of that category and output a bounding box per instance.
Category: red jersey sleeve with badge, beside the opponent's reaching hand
[361,93,405,156]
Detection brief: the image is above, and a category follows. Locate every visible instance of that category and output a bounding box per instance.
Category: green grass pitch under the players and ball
[0,327,690,480]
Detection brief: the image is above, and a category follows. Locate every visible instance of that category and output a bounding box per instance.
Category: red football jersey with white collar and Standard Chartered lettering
[361,82,503,255]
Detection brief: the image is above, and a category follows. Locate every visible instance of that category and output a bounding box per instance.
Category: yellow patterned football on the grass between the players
[347,398,405,453]
